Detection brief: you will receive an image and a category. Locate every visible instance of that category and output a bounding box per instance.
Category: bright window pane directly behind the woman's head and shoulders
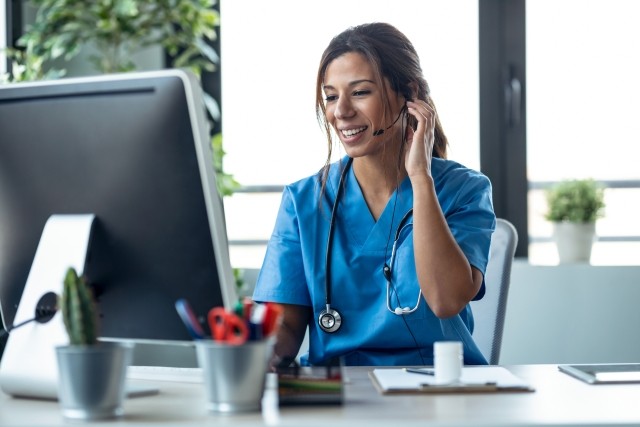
[220,0,479,268]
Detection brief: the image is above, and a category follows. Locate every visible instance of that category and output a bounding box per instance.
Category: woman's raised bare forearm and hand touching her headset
[405,101,482,318]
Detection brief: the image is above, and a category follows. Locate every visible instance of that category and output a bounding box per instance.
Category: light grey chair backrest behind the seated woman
[471,218,518,365]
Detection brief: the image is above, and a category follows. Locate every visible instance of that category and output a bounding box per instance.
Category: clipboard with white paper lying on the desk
[369,366,535,394]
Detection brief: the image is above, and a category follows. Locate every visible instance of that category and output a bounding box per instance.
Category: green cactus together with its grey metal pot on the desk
[56,267,133,420]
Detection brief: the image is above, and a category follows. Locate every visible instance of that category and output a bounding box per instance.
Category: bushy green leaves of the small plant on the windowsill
[545,179,605,223]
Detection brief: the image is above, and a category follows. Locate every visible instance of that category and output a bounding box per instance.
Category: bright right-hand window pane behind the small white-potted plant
[526,0,640,265]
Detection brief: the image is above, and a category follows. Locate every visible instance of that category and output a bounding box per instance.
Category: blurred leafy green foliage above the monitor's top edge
[7,0,220,77]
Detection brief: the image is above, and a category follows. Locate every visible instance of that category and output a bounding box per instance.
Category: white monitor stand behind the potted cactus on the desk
[0,214,158,399]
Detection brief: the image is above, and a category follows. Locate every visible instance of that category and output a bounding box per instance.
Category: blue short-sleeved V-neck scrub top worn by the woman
[253,157,495,366]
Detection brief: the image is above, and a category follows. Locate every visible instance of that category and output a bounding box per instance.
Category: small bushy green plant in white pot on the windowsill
[545,178,605,263]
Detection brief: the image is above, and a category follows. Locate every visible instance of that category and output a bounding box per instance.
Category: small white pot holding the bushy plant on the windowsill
[553,221,596,264]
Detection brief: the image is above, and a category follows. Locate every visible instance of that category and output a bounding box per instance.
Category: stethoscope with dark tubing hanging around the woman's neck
[318,158,422,333]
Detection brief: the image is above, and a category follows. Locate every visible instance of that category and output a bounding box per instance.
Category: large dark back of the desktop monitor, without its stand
[0,70,235,348]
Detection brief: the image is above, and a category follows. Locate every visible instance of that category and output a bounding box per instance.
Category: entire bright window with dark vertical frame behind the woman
[7,0,640,268]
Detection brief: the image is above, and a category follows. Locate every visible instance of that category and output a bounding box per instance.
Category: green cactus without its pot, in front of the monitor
[59,267,98,345]
